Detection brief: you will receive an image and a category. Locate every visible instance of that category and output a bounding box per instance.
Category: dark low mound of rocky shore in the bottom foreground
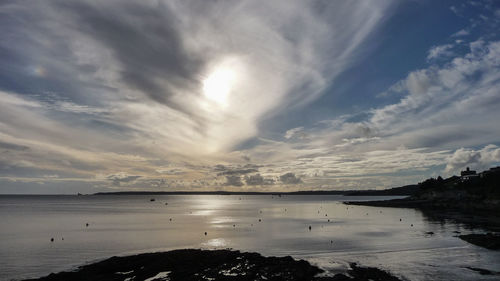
[24,249,400,281]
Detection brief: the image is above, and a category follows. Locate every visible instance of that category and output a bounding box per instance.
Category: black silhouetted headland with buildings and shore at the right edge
[344,167,500,250]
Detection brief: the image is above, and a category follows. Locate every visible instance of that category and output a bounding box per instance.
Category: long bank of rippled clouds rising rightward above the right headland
[233,35,500,189]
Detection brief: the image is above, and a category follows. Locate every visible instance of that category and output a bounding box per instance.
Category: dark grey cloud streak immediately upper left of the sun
[61,2,203,106]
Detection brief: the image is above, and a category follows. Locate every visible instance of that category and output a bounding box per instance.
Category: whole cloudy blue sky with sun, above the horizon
[0,0,500,194]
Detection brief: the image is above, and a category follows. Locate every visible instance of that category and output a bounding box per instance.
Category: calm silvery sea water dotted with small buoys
[0,195,500,280]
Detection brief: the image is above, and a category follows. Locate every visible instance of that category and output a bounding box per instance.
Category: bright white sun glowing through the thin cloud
[203,67,235,106]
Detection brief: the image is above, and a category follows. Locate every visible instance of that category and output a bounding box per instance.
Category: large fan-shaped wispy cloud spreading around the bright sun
[0,0,392,157]
